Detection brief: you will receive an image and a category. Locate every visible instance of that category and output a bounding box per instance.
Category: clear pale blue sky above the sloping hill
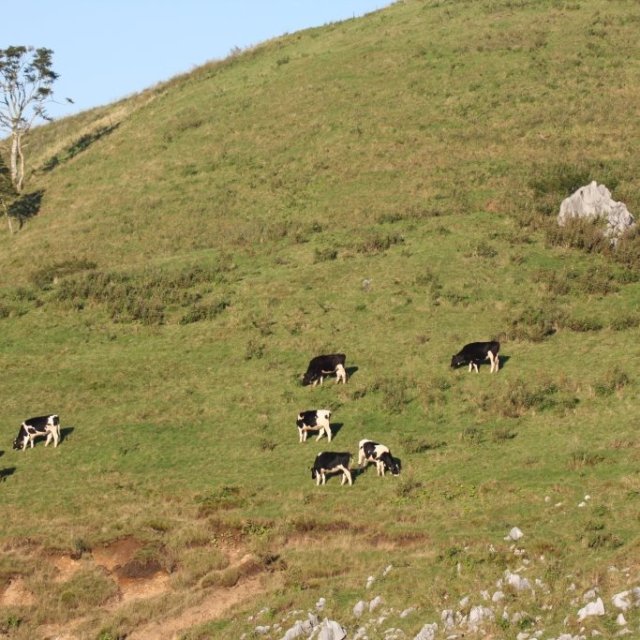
[0,0,392,118]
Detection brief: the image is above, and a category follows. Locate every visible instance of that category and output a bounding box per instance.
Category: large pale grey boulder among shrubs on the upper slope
[558,180,635,240]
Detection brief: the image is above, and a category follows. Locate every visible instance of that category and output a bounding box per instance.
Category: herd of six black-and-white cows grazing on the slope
[7,341,500,485]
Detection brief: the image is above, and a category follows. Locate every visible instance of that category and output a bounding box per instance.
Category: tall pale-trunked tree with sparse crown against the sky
[0,47,58,193]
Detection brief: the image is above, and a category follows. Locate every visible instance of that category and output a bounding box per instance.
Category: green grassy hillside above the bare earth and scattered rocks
[0,0,640,637]
